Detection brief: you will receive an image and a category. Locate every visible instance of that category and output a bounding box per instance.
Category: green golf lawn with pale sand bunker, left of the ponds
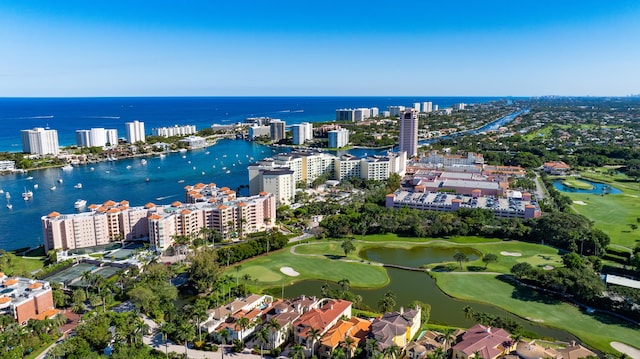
[226,248,389,288]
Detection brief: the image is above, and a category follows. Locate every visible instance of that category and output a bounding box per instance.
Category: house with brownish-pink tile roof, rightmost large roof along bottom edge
[451,324,516,359]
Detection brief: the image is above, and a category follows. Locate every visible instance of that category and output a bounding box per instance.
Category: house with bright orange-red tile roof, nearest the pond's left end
[293,298,353,355]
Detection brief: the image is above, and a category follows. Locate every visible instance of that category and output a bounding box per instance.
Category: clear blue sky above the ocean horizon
[0,0,640,97]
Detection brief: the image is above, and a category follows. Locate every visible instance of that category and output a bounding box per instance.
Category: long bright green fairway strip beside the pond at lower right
[434,273,640,353]
